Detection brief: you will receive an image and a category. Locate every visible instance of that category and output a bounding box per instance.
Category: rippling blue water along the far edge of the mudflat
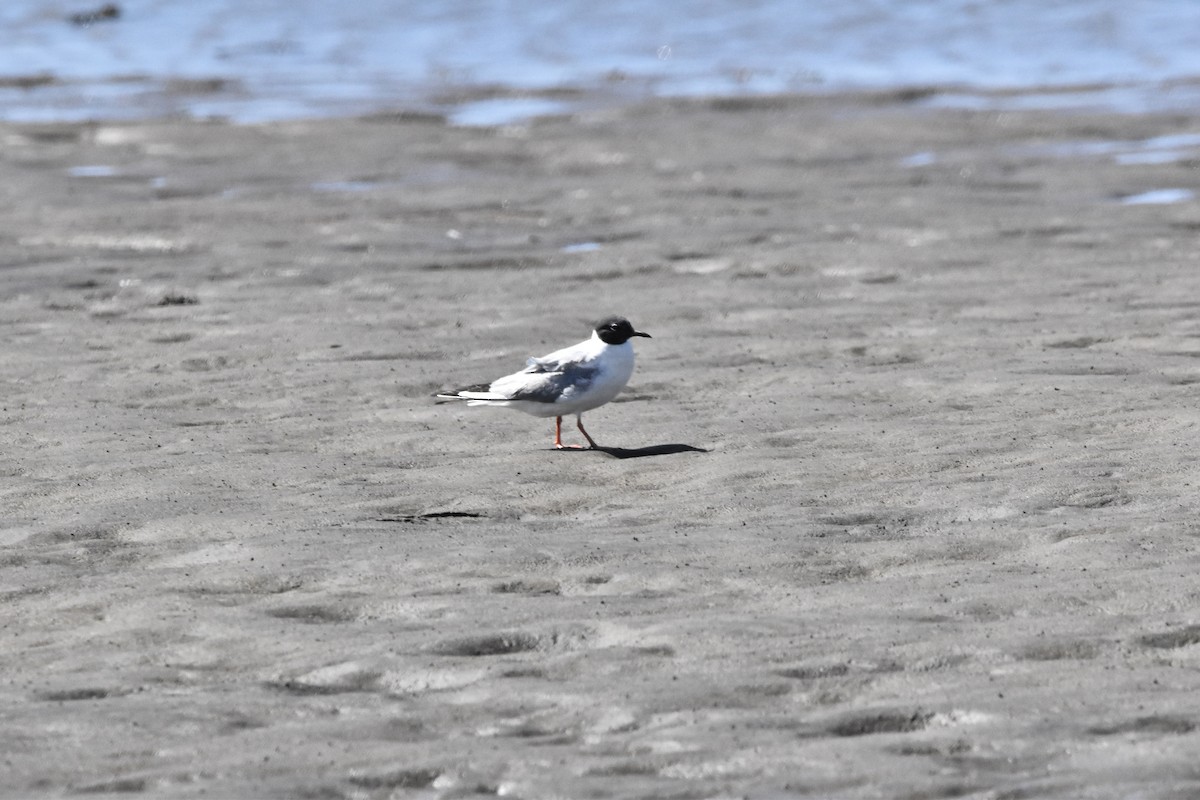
[0,0,1200,125]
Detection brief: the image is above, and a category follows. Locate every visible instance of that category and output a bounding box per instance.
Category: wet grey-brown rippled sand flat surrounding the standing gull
[0,96,1200,799]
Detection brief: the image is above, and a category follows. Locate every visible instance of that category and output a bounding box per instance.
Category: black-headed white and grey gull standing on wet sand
[437,317,653,450]
